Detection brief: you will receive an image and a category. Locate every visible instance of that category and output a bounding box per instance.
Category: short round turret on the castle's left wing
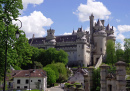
[45,28,56,49]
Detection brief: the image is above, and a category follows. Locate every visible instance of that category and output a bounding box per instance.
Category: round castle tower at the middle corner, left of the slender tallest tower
[76,28,89,67]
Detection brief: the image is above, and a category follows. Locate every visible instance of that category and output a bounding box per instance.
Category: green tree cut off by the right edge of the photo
[124,39,130,63]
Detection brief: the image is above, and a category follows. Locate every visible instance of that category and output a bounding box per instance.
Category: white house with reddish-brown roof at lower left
[0,69,47,91]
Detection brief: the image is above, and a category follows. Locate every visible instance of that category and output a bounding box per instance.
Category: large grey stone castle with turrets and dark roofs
[29,14,116,67]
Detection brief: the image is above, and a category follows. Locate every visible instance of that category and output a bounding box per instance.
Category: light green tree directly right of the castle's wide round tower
[106,40,116,64]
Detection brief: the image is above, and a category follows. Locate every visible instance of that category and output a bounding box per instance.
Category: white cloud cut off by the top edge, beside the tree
[22,0,44,10]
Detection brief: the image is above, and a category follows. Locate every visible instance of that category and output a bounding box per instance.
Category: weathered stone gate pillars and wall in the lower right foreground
[84,61,126,91]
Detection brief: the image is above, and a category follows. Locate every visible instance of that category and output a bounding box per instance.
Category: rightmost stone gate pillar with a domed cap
[115,61,126,91]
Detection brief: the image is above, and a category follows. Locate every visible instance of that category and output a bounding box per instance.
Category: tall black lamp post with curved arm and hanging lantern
[3,19,22,91]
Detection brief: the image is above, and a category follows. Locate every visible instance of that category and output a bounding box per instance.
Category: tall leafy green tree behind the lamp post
[0,0,31,78]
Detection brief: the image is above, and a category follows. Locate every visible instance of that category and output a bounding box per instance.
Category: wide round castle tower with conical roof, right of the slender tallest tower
[93,20,107,64]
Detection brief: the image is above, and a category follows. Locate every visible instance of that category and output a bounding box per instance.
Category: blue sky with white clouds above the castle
[18,0,130,48]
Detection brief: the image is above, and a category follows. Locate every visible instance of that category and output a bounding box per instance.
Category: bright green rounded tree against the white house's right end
[43,67,56,85]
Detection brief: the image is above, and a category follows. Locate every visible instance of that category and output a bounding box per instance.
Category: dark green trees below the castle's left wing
[31,47,68,66]
